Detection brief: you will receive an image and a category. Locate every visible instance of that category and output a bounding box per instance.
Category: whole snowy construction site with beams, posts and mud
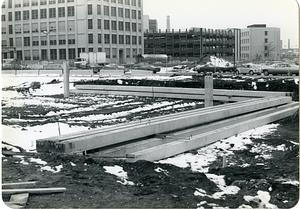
[2,56,299,208]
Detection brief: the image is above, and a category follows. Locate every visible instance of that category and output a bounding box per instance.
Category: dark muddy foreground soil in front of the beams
[2,117,299,208]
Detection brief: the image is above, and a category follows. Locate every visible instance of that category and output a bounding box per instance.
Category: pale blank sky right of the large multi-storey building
[143,0,300,48]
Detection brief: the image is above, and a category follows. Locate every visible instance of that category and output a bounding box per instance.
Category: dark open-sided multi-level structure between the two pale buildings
[144,28,235,61]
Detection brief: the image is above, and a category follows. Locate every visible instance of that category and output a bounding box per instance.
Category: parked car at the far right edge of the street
[262,63,299,76]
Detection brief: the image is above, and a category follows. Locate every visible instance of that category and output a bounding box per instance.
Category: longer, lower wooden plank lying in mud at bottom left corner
[2,187,66,195]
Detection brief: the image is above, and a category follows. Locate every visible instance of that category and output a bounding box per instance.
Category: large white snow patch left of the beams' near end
[2,122,88,151]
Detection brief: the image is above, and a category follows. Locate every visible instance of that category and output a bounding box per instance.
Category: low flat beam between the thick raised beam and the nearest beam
[95,102,299,158]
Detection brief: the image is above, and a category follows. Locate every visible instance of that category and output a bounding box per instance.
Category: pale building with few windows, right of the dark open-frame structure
[241,24,281,61]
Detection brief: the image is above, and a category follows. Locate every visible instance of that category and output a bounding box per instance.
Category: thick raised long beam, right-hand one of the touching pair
[46,97,291,153]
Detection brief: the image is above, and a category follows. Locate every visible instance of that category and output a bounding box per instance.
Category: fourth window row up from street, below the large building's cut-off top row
[1,5,142,21]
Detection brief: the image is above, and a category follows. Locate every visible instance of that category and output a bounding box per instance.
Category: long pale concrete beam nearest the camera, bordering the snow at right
[127,104,299,162]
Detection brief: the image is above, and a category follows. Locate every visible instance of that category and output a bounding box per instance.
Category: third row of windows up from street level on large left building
[2,19,142,34]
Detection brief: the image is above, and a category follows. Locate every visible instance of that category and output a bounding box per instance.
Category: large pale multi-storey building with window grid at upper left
[2,0,143,63]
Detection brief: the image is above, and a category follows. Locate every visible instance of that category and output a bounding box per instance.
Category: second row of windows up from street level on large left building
[2,34,142,47]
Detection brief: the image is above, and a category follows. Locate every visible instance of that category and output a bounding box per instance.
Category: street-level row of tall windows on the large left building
[10,48,142,60]
